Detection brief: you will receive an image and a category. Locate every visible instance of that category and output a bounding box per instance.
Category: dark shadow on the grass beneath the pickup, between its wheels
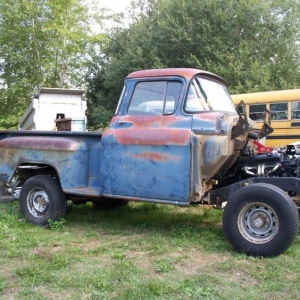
[66,202,231,252]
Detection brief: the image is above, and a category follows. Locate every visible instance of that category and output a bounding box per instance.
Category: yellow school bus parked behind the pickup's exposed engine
[231,89,300,147]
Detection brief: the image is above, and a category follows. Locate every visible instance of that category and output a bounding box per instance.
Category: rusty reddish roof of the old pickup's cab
[126,68,227,85]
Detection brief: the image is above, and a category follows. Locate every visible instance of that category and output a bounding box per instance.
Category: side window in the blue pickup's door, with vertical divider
[127,81,181,115]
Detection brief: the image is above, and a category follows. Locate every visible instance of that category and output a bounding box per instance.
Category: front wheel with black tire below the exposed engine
[223,183,299,257]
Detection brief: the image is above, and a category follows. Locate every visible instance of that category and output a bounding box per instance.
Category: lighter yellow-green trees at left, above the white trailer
[0,0,105,128]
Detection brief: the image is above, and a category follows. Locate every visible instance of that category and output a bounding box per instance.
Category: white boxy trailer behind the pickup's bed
[18,88,86,131]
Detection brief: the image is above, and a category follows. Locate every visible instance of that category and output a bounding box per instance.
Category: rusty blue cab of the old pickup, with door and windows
[102,69,248,205]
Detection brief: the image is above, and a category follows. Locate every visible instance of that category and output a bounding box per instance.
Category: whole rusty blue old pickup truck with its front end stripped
[0,68,300,257]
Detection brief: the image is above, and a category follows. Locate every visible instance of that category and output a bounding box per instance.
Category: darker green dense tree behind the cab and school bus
[88,0,300,124]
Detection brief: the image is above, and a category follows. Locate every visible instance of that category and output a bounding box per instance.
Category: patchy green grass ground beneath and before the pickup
[0,203,300,300]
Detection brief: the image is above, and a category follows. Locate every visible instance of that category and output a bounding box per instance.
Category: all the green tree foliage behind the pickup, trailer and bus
[0,0,300,130]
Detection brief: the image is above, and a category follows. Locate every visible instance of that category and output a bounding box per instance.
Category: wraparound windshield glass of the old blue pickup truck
[184,77,235,113]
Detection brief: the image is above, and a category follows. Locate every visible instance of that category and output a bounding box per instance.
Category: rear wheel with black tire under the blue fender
[20,175,67,226]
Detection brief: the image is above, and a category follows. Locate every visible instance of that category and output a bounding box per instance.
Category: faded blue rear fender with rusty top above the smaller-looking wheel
[0,136,90,189]
